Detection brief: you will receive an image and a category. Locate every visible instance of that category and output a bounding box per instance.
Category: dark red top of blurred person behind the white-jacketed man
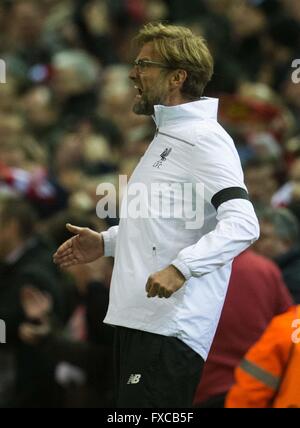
[194,250,293,406]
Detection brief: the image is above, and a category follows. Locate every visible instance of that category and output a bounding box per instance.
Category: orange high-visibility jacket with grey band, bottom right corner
[225,305,300,408]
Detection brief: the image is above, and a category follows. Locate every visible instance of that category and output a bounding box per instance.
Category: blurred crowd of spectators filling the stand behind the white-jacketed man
[0,0,300,407]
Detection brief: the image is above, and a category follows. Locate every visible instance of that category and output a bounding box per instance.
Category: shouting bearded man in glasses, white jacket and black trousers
[54,24,259,407]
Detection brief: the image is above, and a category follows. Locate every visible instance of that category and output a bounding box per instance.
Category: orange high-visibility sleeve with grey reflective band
[225,316,291,408]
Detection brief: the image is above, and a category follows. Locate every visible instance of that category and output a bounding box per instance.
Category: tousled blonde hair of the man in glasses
[134,23,214,98]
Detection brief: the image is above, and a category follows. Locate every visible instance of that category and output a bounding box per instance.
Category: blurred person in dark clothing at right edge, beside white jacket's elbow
[255,208,300,303]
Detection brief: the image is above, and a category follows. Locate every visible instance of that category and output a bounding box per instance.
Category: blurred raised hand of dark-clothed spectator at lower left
[20,286,53,321]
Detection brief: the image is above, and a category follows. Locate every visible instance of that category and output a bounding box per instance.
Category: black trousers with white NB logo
[115,327,204,408]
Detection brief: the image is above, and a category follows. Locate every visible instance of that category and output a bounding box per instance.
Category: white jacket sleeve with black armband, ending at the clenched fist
[172,128,259,280]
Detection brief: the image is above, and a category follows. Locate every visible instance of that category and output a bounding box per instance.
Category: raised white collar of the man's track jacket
[153,98,219,128]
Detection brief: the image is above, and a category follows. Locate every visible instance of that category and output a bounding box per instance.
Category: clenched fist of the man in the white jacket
[146,265,186,299]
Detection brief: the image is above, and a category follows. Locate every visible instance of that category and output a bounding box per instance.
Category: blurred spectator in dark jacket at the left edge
[0,197,62,407]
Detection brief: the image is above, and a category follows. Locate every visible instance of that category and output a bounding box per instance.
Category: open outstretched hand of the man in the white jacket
[53,224,104,268]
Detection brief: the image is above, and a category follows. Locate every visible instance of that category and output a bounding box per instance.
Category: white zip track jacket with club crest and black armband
[103,98,259,360]
